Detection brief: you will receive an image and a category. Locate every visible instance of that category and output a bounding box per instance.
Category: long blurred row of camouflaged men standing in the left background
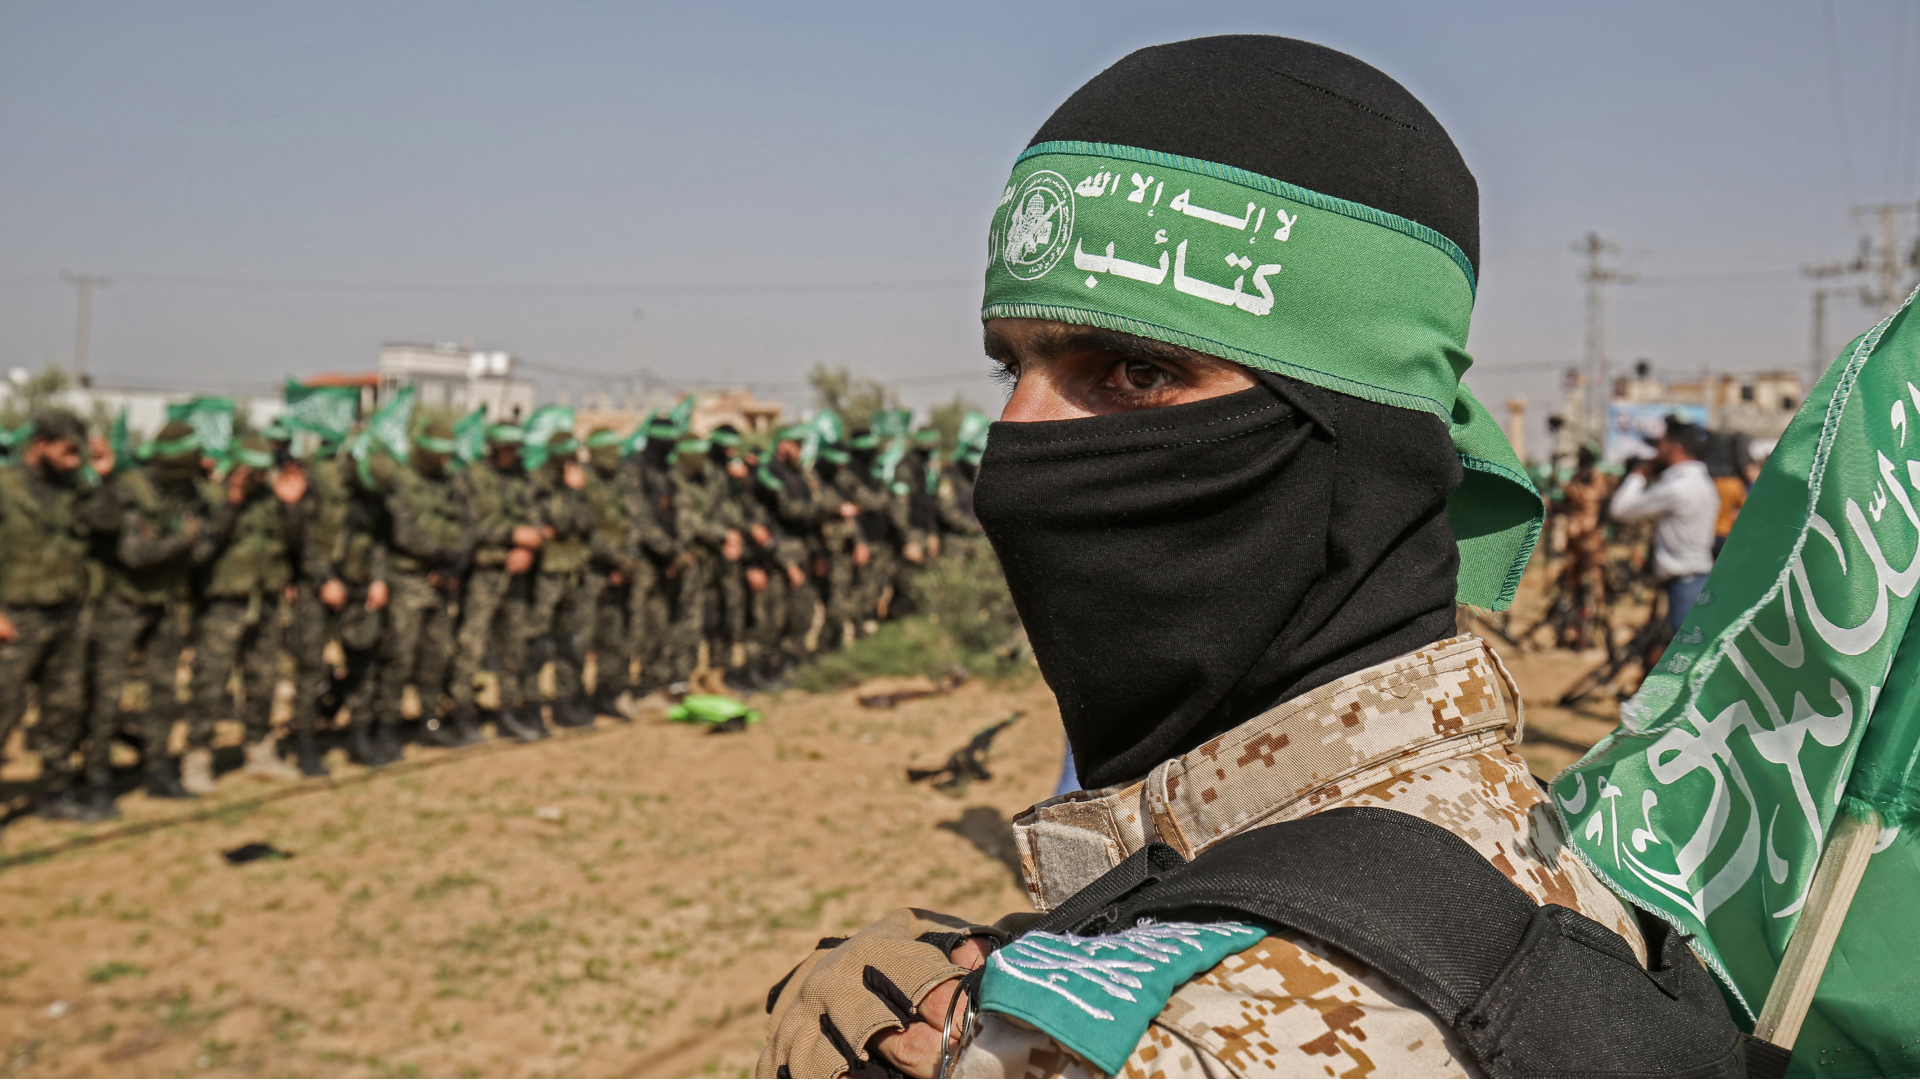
[0,399,987,821]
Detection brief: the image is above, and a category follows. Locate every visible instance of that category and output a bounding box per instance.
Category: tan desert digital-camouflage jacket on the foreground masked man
[954,636,1645,1076]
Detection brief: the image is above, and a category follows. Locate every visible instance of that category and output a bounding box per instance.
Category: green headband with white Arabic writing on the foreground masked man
[981,142,1544,607]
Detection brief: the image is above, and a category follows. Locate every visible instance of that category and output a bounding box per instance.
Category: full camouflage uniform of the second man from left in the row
[88,449,232,798]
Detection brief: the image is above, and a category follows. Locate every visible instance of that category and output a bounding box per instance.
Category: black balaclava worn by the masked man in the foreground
[973,37,1478,788]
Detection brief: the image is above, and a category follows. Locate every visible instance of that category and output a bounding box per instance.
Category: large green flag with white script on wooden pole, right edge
[1553,290,1920,1076]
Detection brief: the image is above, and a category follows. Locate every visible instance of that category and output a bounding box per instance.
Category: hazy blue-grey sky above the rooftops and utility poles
[0,0,1920,445]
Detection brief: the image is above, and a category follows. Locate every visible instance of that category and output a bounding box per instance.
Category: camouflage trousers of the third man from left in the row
[186,596,280,748]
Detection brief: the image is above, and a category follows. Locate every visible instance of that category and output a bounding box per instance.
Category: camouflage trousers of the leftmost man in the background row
[0,600,86,782]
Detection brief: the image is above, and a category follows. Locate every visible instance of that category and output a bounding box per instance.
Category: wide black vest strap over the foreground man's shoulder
[1033,807,1789,1076]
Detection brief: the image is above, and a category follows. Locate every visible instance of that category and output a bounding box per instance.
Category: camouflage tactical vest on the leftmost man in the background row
[0,465,86,607]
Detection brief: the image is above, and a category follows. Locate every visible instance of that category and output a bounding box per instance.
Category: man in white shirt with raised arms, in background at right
[1607,417,1720,634]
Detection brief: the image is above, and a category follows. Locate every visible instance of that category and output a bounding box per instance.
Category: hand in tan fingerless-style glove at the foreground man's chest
[755,907,1008,1080]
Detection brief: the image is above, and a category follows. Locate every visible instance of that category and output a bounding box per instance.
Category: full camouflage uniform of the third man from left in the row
[186,463,300,749]
